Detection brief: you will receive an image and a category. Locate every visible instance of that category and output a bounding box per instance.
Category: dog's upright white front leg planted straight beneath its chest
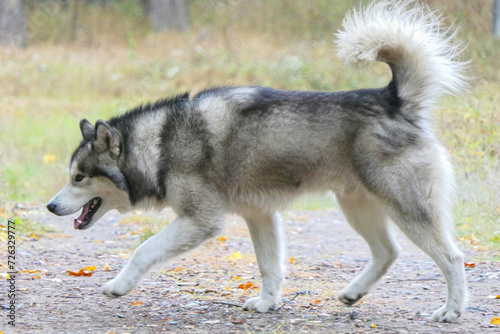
[243,212,283,312]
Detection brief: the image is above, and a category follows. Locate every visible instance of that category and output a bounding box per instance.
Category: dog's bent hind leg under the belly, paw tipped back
[337,190,400,305]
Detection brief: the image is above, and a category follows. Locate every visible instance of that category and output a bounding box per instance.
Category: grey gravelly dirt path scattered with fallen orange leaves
[4,205,500,333]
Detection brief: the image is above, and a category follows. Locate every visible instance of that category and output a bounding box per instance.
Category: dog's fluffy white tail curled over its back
[336,0,467,112]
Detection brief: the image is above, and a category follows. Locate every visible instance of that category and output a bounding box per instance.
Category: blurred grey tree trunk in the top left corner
[0,0,26,47]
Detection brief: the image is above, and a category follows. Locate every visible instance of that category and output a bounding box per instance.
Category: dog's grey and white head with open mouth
[47,119,130,230]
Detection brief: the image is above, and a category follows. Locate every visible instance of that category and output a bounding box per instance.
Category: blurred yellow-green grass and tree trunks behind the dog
[0,0,500,254]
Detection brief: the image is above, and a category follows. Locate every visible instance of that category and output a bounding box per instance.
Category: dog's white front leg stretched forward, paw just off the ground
[102,217,222,298]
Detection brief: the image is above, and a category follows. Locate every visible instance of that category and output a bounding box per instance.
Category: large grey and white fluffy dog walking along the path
[47,0,467,322]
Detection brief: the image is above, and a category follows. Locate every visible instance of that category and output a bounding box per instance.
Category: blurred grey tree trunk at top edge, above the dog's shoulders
[142,0,189,31]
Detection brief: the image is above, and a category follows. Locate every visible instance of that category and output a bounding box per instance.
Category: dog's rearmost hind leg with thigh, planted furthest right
[362,147,467,322]
